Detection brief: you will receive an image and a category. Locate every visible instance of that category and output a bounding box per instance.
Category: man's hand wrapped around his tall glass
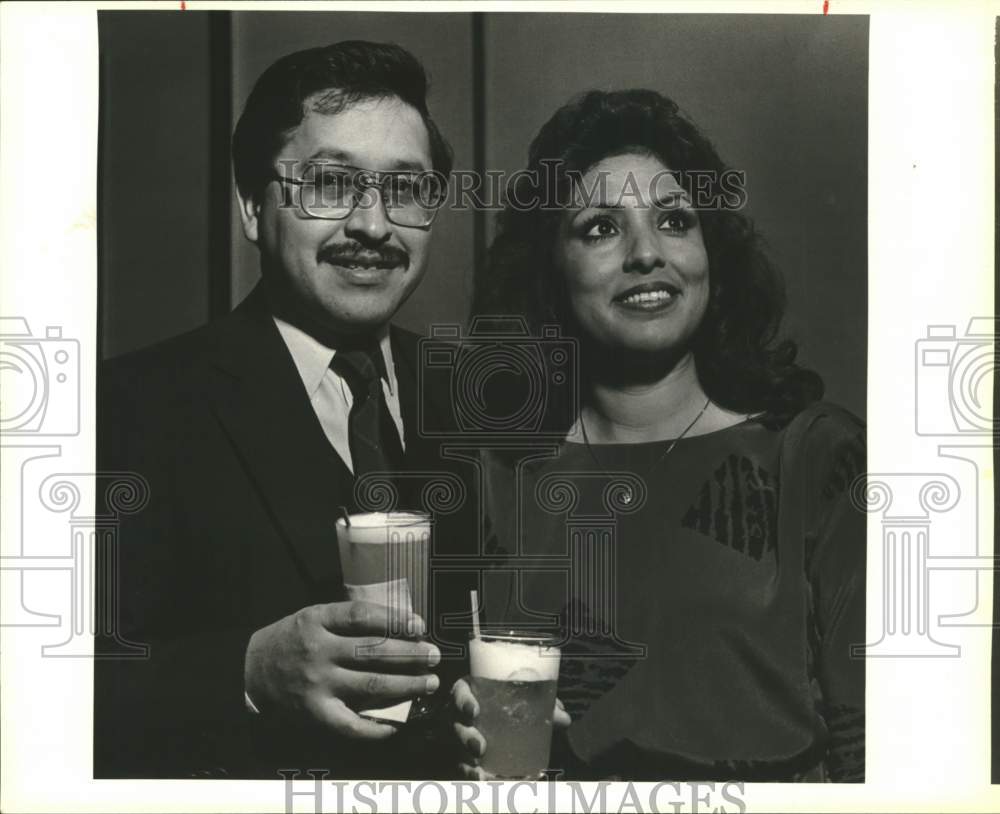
[243,602,441,740]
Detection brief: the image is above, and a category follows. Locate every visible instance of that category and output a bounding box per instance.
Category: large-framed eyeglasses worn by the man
[274,163,447,228]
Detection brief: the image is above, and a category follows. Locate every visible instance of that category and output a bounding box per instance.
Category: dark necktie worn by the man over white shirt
[330,345,403,478]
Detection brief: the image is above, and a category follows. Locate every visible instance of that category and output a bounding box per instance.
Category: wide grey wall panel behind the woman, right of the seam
[484,13,868,415]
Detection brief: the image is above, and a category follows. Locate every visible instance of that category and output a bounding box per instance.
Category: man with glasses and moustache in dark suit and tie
[95,42,464,778]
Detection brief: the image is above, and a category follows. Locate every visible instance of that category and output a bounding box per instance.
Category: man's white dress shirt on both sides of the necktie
[274,317,406,472]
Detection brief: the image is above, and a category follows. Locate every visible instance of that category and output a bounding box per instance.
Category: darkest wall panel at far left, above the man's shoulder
[98,11,212,358]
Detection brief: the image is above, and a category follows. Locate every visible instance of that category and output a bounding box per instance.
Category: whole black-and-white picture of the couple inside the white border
[94,6,867,782]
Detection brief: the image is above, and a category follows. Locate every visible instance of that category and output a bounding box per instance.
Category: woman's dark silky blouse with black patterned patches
[483,403,865,782]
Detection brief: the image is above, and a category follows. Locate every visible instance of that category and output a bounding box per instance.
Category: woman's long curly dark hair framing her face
[472,89,823,428]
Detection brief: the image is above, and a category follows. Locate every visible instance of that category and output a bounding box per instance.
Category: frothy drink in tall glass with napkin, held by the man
[337,512,431,723]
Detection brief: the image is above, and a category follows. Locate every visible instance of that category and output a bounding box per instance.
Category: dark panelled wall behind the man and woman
[99,12,868,415]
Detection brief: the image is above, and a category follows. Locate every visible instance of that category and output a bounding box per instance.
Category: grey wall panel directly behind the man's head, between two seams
[232,12,473,333]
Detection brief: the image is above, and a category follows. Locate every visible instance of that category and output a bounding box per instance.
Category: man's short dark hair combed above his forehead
[233,40,452,206]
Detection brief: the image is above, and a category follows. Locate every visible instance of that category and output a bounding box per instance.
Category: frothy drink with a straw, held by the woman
[469,631,559,779]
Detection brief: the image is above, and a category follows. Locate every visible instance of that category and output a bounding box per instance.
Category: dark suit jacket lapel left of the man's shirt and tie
[207,289,353,601]
